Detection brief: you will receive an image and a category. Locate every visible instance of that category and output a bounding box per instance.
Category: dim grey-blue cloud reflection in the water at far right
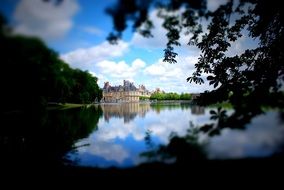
[209,112,284,158]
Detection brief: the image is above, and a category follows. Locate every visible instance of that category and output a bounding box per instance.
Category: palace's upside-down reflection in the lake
[101,103,150,123]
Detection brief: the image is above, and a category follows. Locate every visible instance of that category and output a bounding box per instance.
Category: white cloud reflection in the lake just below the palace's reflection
[98,105,209,143]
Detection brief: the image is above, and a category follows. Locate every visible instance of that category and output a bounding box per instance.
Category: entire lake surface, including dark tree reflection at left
[3,103,284,167]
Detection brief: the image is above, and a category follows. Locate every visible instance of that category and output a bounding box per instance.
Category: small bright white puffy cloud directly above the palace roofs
[96,59,146,80]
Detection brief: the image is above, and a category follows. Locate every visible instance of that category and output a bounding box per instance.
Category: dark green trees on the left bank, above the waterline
[0,16,102,112]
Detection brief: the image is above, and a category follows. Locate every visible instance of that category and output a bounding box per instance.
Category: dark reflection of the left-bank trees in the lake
[0,107,102,167]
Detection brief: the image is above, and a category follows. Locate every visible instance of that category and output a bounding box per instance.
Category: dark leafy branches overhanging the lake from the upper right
[108,0,284,131]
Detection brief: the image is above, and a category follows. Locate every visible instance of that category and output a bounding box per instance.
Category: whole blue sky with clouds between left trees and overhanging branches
[0,0,254,93]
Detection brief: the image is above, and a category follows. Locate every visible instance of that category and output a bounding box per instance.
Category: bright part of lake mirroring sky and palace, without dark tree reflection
[66,102,284,168]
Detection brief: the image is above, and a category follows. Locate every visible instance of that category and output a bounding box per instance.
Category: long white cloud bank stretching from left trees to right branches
[61,42,207,93]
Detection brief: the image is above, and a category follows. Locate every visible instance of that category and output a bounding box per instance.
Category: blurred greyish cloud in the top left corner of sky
[13,0,79,40]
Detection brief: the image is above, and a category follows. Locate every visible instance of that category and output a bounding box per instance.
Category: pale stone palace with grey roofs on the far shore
[102,80,151,103]
